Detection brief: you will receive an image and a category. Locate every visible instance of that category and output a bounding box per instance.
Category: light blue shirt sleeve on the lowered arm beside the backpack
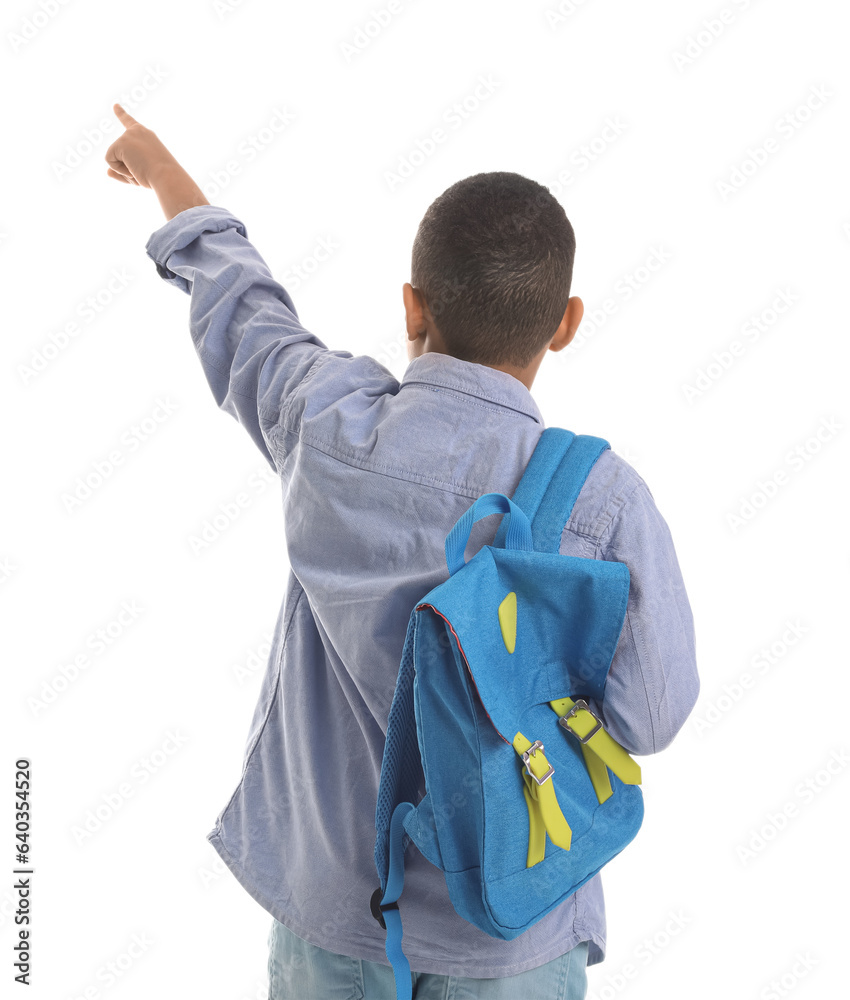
[588,479,700,754]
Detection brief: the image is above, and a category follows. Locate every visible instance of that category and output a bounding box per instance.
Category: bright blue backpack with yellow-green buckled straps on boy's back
[371,428,643,1000]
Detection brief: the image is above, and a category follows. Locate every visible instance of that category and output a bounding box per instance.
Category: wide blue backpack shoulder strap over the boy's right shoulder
[493,427,610,552]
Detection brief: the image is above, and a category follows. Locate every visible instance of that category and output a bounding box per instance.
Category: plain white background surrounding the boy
[0,0,850,1000]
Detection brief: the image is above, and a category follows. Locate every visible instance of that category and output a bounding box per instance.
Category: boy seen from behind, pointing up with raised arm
[106,105,699,1000]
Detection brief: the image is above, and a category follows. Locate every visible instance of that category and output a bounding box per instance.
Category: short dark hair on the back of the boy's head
[411,171,575,368]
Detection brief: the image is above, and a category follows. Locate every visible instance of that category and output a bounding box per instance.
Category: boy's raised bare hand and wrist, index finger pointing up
[105,104,209,219]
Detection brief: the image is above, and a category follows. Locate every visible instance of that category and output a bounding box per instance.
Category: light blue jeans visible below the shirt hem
[269,920,587,1000]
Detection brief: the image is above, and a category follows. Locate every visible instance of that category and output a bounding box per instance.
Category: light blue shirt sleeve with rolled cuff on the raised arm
[145,205,330,472]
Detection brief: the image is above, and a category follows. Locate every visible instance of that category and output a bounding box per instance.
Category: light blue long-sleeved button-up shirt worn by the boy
[145,205,699,978]
